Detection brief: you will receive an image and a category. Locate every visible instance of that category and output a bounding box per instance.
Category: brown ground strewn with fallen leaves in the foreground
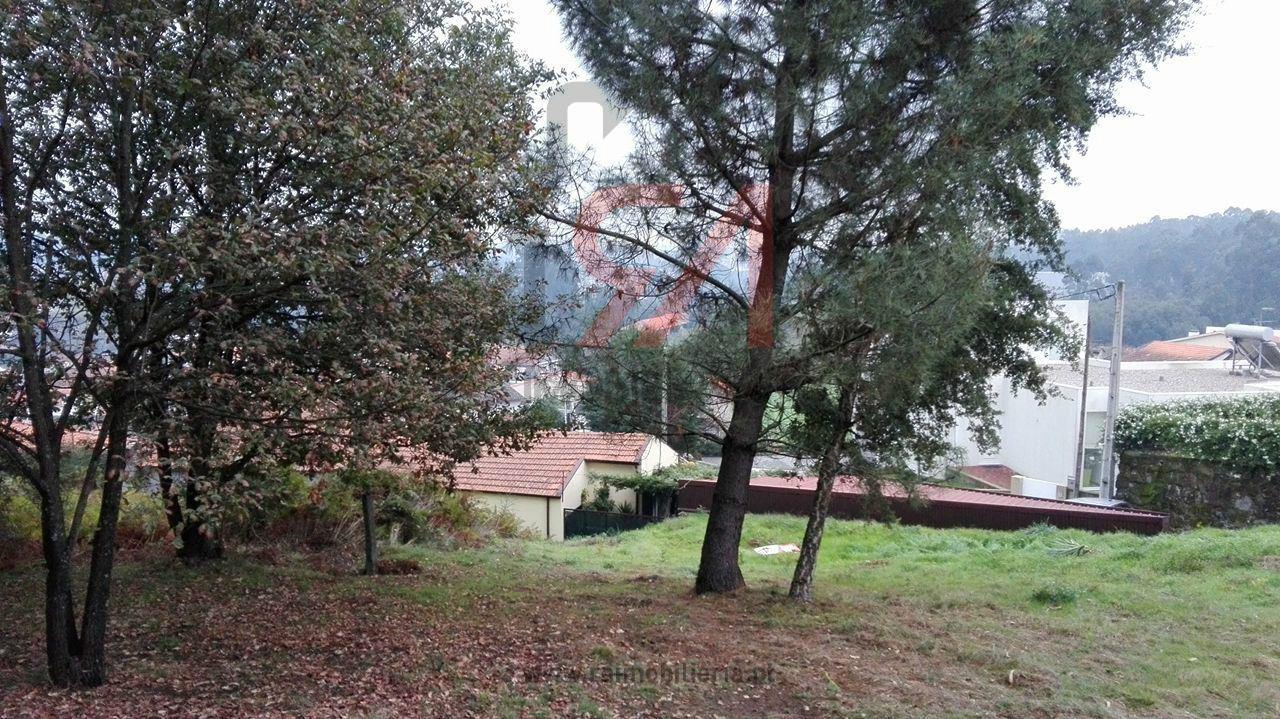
[0,550,1087,718]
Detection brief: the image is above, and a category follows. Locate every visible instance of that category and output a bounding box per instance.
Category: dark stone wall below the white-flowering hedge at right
[1116,452,1280,528]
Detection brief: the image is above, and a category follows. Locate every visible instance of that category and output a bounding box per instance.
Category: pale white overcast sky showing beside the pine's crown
[494,0,1280,229]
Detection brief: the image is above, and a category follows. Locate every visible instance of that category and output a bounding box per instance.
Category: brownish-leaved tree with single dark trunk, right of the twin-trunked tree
[131,3,538,559]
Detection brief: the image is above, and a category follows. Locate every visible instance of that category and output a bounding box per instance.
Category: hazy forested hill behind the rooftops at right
[1062,209,1280,345]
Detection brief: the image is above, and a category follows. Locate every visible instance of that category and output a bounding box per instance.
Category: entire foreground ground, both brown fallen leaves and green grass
[0,518,1280,718]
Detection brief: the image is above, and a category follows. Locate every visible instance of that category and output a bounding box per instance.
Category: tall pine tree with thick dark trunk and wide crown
[548,0,1192,592]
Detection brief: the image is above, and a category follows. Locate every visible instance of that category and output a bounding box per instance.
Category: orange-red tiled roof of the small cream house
[453,432,650,496]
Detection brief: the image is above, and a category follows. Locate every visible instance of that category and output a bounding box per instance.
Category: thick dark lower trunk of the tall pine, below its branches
[694,397,767,594]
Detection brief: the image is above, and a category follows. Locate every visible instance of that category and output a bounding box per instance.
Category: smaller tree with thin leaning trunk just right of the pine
[782,237,1076,601]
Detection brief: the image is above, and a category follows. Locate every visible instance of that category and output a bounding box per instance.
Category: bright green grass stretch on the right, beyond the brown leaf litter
[391,516,1280,716]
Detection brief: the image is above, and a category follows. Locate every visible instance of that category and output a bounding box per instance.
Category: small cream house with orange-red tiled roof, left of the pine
[454,431,678,540]
